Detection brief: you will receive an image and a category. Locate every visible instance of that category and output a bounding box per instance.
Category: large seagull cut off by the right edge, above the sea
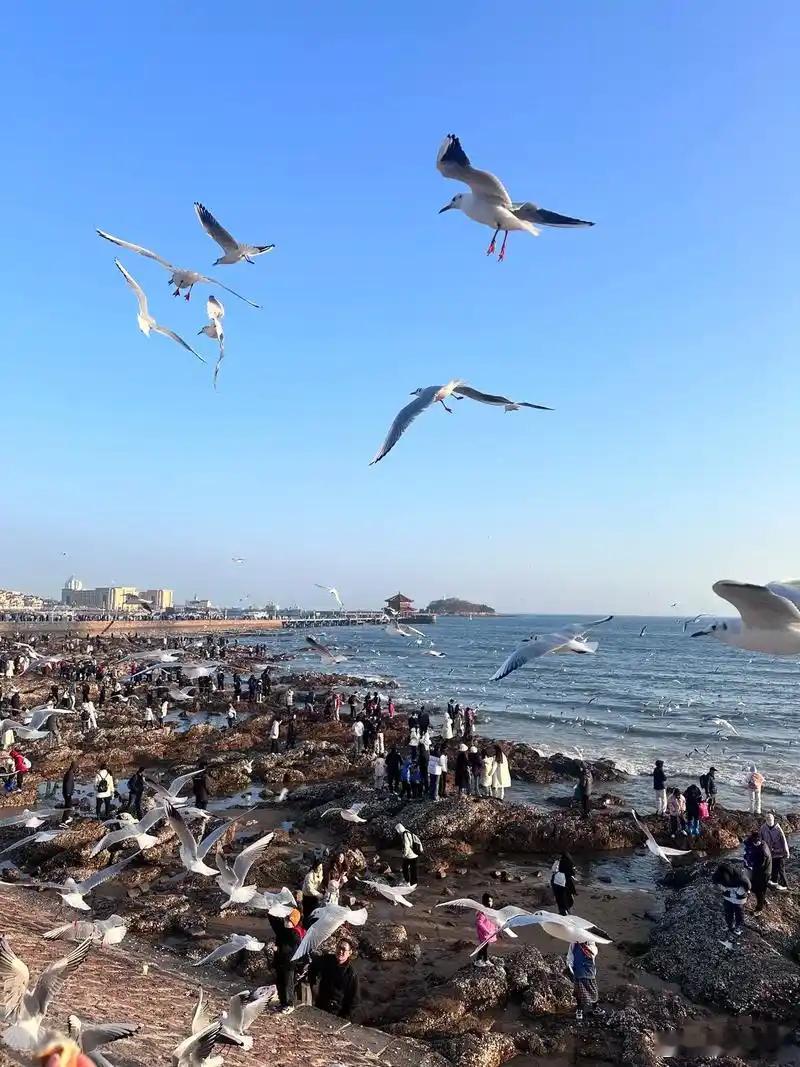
[691,580,800,656]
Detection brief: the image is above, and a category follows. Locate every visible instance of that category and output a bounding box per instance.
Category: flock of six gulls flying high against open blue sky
[97,133,594,465]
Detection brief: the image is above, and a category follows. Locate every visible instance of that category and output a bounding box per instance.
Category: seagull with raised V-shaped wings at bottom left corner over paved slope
[0,938,92,1051]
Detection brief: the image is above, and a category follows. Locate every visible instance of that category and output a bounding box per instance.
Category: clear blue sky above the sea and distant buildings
[0,0,800,614]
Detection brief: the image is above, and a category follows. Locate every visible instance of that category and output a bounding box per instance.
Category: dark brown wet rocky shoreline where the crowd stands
[0,627,800,1067]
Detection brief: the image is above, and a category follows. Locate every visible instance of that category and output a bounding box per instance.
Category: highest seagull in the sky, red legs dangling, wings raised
[436,133,594,260]
